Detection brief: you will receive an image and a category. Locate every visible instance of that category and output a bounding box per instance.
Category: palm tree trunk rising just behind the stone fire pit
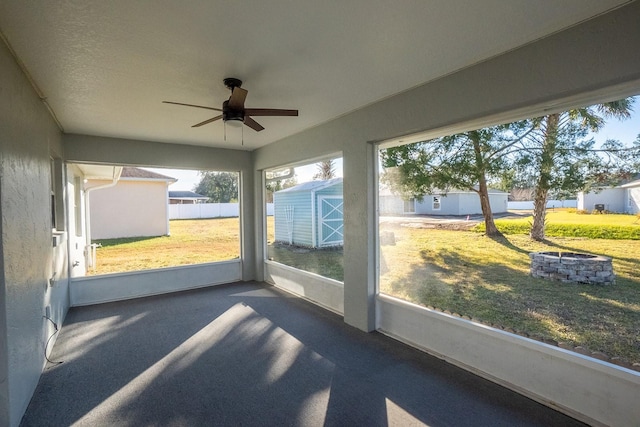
[530,114,560,241]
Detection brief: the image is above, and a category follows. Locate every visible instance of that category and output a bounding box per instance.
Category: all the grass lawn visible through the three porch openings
[92,216,640,363]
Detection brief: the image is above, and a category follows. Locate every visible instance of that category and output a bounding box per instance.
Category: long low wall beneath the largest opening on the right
[376,295,640,426]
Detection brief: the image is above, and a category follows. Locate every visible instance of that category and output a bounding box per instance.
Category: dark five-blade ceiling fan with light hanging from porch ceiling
[162,77,298,132]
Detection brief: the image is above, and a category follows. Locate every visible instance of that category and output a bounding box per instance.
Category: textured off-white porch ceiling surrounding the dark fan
[0,0,627,150]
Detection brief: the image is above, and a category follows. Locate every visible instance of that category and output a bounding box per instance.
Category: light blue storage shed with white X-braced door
[273,178,343,248]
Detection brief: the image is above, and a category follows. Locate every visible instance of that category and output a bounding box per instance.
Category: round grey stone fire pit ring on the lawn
[529,252,615,286]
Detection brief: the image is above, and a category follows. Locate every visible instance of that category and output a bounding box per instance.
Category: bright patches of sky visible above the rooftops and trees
[144,97,640,191]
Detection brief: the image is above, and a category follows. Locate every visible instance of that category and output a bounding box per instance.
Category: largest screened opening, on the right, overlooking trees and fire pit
[378,96,640,363]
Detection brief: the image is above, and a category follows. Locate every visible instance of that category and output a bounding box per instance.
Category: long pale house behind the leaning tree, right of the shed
[378,188,509,215]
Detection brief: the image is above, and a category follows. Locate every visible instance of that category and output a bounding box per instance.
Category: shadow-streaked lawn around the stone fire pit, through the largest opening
[380,226,640,362]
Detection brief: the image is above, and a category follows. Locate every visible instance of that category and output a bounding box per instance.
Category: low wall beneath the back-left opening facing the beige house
[70,260,242,306]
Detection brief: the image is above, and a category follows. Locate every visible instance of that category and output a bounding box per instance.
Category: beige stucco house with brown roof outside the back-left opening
[86,167,176,240]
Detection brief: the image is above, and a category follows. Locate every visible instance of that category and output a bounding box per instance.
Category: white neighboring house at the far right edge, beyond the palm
[578,179,640,214]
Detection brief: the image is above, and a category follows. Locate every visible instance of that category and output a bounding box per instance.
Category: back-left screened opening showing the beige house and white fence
[70,165,240,275]
